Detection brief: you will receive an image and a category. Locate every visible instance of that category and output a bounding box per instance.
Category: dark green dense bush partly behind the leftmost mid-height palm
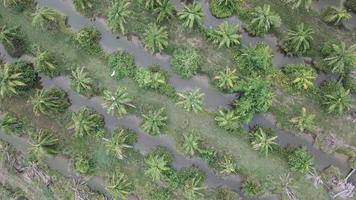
[10,60,38,92]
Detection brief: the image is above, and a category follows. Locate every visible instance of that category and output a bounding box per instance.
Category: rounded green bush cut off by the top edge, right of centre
[209,0,236,18]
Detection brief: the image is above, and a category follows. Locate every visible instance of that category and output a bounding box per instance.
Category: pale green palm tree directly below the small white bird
[103,88,135,116]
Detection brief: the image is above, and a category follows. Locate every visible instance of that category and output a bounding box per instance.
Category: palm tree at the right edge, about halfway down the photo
[320,81,353,115]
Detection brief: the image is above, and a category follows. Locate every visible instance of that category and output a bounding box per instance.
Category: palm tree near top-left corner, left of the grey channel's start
[32,7,64,29]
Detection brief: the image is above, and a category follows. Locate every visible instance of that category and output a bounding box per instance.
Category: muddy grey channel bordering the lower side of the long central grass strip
[41,76,250,198]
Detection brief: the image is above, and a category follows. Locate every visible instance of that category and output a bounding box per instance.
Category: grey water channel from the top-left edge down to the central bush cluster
[36,0,235,110]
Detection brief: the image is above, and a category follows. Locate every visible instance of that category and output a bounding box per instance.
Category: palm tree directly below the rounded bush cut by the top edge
[208,22,241,48]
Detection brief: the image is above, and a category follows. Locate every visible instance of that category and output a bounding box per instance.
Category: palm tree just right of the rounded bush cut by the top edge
[248,4,282,35]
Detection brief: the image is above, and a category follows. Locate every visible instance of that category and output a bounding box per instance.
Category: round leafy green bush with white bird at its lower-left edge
[108,51,135,80]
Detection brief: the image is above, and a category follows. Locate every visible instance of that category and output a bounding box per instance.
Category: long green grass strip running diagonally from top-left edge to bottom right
[0,3,332,199]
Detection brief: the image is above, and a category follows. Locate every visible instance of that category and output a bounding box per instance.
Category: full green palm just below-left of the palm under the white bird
[69,107,105,137]
